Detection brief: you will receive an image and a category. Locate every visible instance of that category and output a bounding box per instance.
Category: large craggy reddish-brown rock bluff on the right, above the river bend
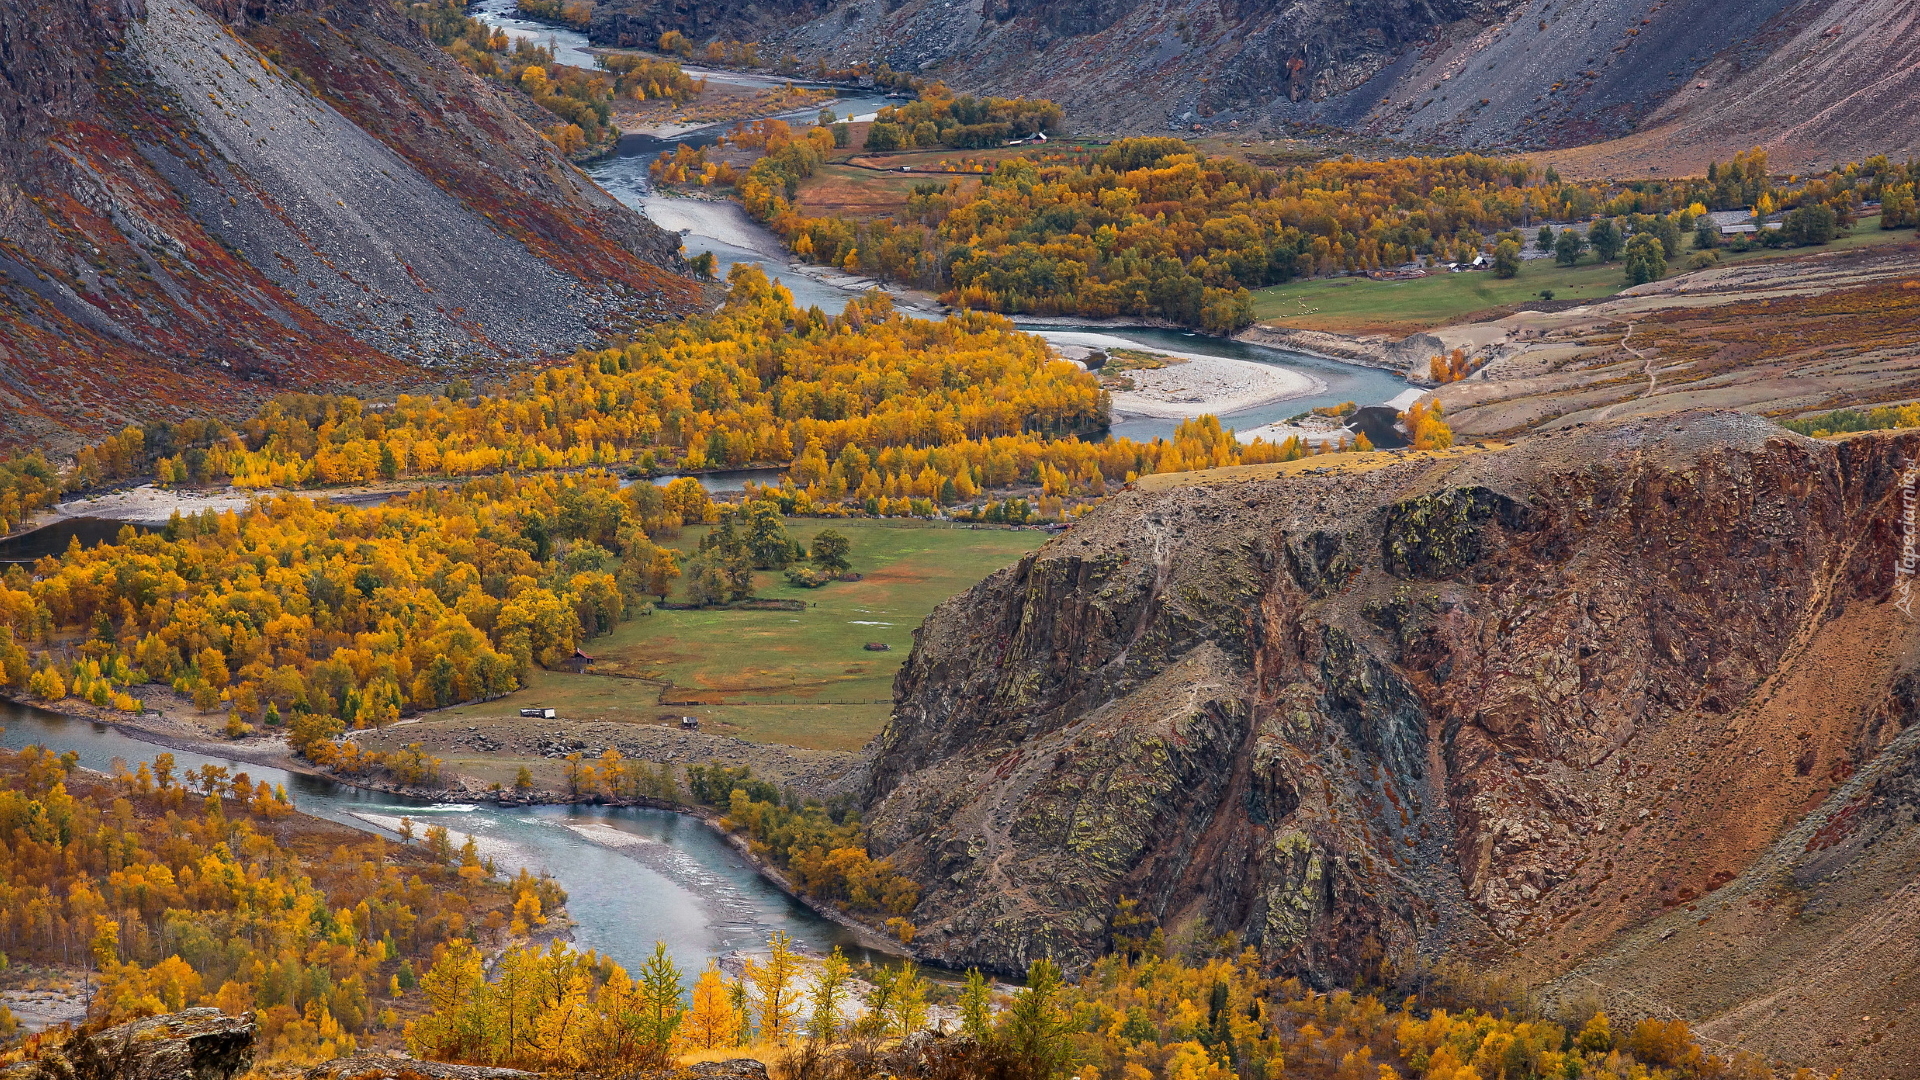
[870,413,1920,1060]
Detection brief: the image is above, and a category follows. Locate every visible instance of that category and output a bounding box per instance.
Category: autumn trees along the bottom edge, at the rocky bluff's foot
[1029,926,1811,1080]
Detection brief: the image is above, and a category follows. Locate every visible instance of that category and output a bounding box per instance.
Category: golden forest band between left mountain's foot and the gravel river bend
[56,263,1320,507]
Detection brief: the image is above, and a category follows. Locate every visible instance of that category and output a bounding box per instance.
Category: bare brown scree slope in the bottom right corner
[1546,680,1920,1080]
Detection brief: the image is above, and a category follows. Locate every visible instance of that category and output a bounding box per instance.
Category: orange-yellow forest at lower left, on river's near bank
[0,748,564,1061]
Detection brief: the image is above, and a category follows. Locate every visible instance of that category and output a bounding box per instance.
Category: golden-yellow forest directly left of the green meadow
[0,473,668,782]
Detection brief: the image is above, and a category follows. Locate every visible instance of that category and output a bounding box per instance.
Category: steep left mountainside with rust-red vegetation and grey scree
[0,0,695,446]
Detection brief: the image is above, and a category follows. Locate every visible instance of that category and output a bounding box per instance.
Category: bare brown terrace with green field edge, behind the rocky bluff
[1240,229,1920,438]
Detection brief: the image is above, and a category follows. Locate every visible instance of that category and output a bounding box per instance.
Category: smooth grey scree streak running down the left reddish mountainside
[142,4,633,361]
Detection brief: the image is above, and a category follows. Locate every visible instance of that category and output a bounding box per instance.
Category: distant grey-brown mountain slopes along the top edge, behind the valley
[591,0,1920,168]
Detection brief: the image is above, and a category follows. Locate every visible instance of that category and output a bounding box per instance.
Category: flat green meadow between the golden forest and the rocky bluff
[7,518,1046,798]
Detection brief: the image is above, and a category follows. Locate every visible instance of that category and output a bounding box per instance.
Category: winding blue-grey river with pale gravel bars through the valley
[0,10,1405,974]
